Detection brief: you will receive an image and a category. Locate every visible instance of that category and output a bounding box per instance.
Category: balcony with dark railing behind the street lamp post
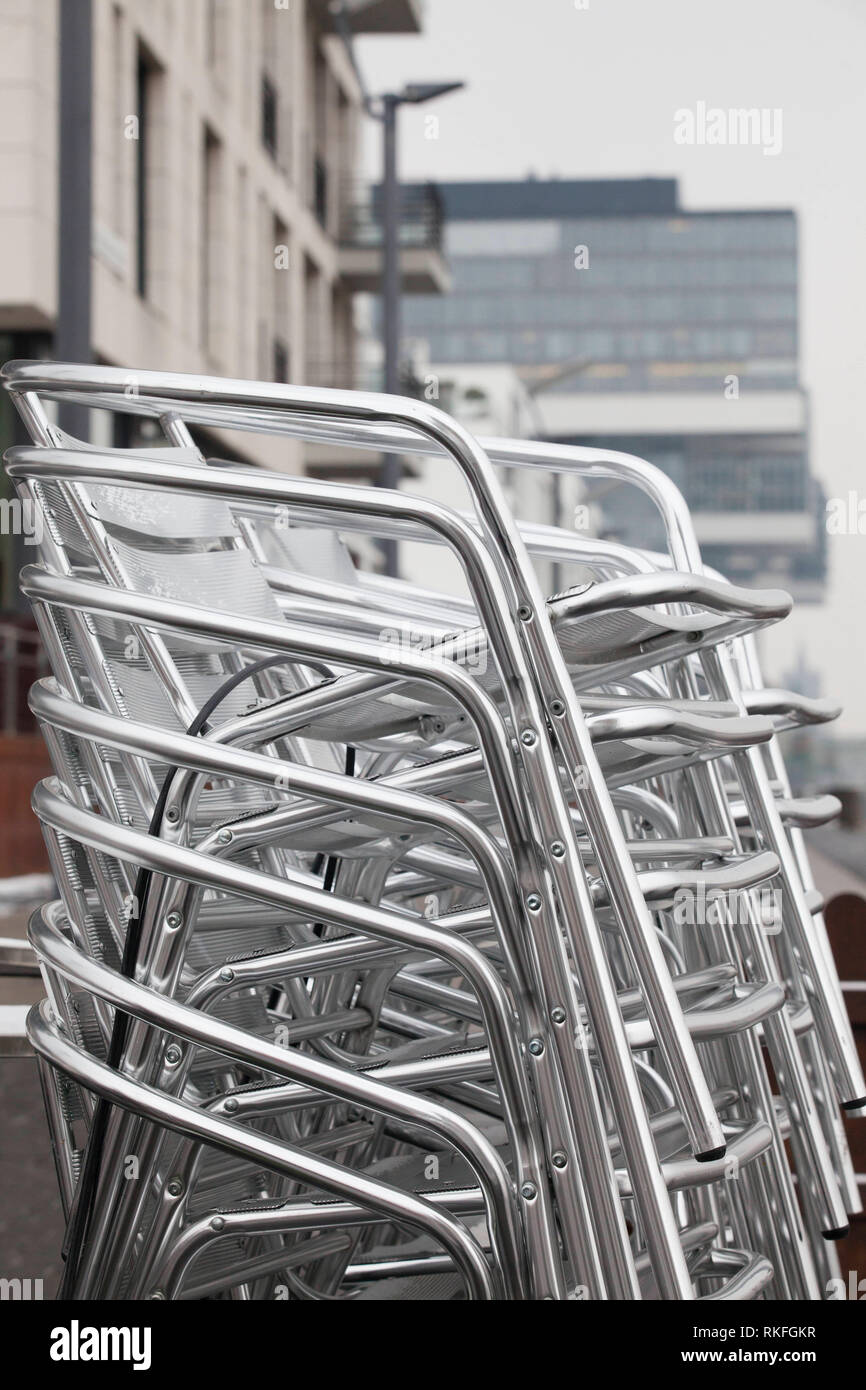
[338,183,450,295]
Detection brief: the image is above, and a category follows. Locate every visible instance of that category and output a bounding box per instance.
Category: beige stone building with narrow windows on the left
[0,0,446,471]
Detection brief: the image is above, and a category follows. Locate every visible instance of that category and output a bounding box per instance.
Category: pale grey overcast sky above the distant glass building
[359,0,866,734]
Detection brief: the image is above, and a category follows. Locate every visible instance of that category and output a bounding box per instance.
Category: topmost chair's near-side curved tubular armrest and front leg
[7,366,723,1195]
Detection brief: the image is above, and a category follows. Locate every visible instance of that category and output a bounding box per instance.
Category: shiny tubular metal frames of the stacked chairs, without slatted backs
[4,364,863,1298]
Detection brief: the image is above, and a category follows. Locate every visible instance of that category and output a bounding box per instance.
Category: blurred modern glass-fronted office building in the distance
[403,179,824,600]
